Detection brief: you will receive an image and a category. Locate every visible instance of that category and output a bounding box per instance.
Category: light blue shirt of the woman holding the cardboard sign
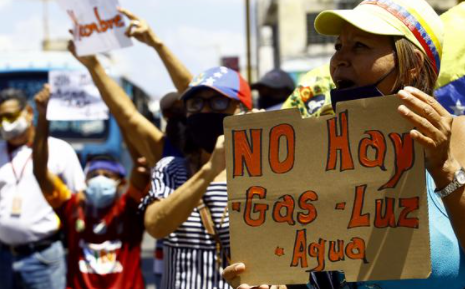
[357,174,465,289]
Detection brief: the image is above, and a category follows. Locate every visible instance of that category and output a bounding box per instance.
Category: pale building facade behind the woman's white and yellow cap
[256,0,460,81]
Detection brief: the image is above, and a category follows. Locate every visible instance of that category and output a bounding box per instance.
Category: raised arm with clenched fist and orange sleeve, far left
[32,84,71,208]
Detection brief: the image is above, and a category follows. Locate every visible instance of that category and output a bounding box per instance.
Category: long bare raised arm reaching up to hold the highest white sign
[69,42,164,166]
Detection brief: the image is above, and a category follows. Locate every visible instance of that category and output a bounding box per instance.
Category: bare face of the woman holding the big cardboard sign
[330,23,397,94]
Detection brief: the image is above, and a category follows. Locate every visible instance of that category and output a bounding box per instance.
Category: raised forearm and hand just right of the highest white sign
[118,8,192,93]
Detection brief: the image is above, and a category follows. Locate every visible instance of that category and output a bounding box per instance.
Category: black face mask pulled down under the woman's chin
[330,67,395,112]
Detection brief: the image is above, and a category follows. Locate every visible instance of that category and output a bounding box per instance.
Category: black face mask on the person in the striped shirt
[187,113,230,154]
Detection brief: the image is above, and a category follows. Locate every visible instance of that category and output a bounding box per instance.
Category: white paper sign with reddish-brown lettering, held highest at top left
[58,0,132,56]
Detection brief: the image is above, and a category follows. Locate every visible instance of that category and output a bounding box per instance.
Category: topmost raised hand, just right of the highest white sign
[118,8,161,47]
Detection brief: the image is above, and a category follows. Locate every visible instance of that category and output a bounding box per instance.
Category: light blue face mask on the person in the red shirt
[86,176,119,209]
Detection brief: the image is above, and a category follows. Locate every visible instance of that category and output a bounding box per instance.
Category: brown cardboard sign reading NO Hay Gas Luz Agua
[225,96,431,285]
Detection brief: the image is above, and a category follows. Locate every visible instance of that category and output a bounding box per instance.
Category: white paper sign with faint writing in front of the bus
[47,71,108,120]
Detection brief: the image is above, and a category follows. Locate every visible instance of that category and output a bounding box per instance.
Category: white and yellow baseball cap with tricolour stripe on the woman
[315,0,444,73]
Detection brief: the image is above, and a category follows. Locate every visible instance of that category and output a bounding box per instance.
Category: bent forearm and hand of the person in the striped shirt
[144,136,226,239]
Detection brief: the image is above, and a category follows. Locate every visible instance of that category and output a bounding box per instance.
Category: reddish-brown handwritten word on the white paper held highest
[68,7,124,40]
